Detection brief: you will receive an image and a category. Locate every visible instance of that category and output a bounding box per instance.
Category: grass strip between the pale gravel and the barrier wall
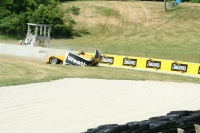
[0,55,200,86]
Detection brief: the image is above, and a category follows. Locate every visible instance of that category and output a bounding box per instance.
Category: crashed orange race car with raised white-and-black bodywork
[46,50,102,66]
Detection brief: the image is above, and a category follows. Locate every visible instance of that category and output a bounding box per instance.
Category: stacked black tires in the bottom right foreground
[82,110,200,133]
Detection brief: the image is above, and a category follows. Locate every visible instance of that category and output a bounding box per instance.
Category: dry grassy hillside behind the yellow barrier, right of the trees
[52,1,200,62]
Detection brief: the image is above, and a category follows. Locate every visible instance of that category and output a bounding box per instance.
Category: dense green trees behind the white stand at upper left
[0,0,79,37]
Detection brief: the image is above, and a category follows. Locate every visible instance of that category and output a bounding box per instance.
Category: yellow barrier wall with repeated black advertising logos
[96,54,200,76]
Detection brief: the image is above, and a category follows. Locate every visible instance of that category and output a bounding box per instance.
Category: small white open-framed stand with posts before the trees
[25,23,50,47]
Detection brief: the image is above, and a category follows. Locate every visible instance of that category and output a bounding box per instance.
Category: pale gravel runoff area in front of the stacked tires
[0,78,200,133]
